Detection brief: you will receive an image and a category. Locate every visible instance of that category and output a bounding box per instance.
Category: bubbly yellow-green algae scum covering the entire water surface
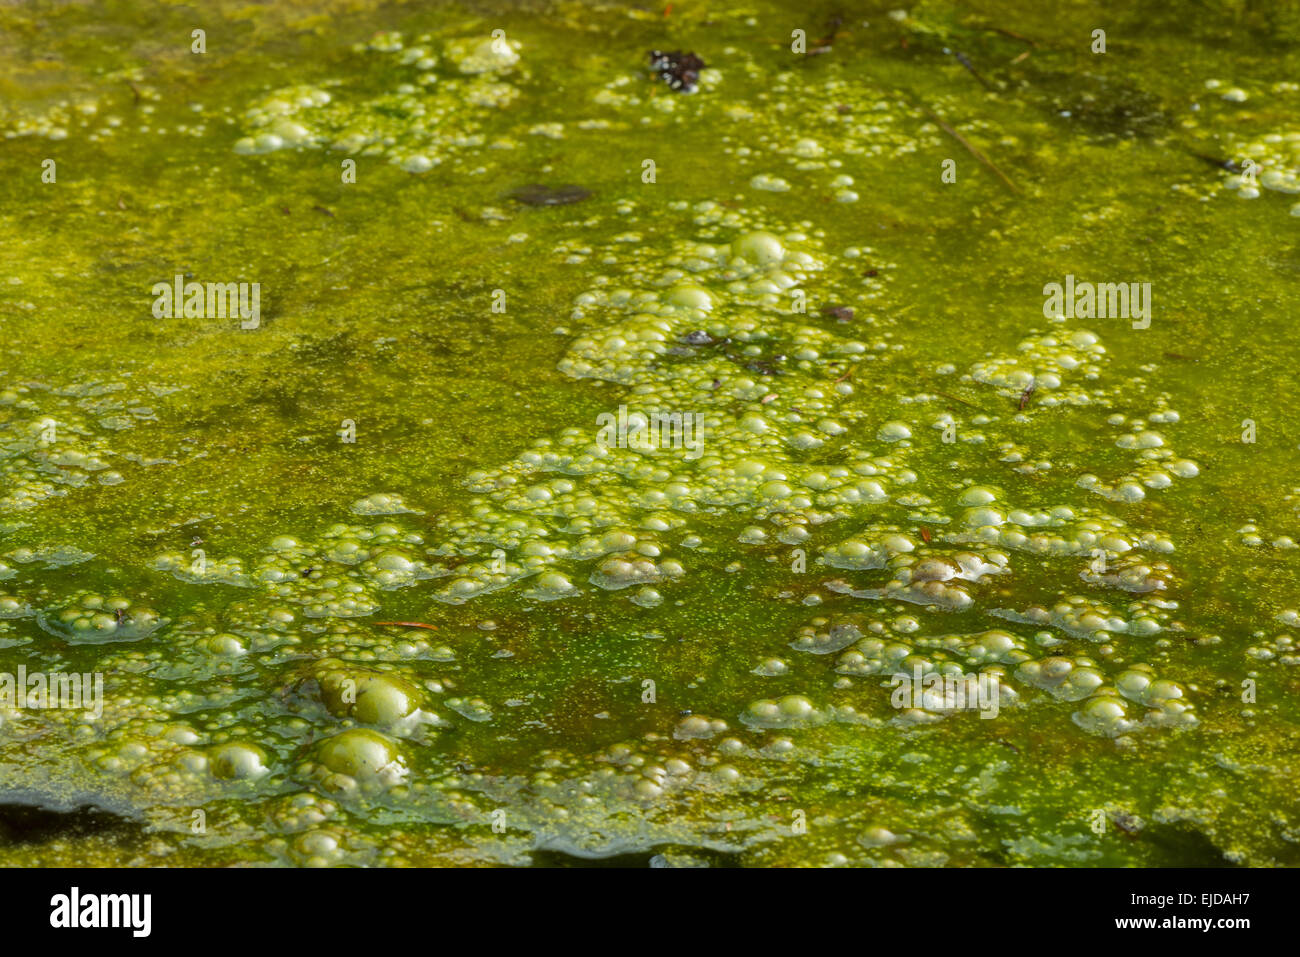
[0,3,1300,866]
